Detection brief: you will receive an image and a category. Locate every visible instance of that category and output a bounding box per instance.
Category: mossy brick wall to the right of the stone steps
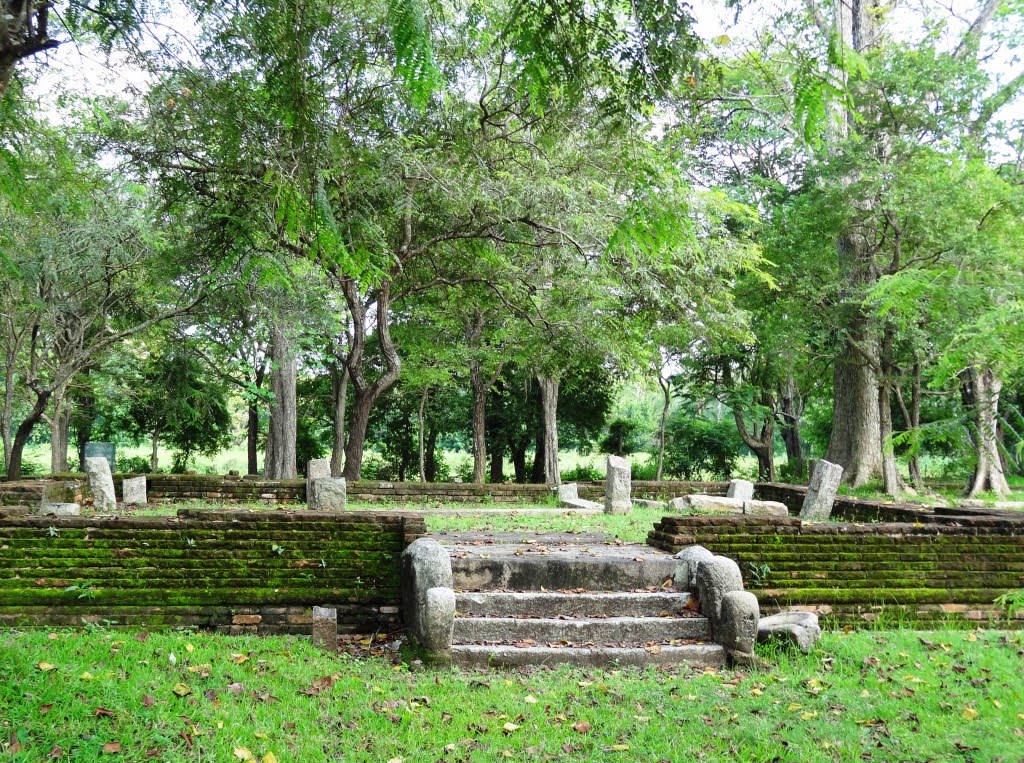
[647,515,1024,627]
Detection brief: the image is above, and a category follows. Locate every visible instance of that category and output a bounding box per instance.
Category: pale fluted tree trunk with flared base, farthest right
[959,364,1010,498]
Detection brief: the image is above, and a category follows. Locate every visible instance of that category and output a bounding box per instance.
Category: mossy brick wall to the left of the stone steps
[0,510,425,633]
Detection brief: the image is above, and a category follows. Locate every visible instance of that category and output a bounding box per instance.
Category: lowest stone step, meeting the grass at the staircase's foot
[452,644,725,668]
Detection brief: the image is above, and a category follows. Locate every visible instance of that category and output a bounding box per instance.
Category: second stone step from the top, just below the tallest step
[455,591,690,618]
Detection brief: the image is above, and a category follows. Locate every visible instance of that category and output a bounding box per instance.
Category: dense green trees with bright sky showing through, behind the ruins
[0,0,1024,496]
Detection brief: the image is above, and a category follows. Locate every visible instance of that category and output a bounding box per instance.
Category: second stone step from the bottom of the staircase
[455,617,711,644]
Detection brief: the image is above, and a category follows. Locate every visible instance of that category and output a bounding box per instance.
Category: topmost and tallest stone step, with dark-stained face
[452,555,677,591]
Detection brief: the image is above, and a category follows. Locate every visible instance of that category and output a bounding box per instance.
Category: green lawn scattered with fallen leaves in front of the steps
[0,630,1024,763]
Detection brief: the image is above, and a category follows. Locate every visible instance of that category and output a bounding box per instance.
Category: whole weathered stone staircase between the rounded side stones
[439,534,726,667]
